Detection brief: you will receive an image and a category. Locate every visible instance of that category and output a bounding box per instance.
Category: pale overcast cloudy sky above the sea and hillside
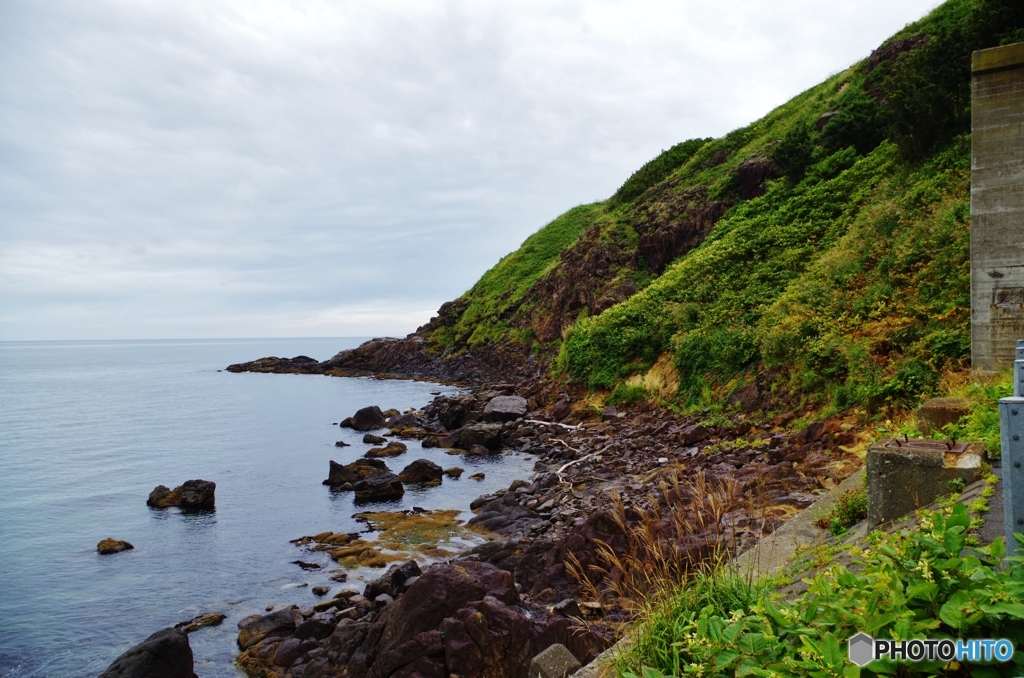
[0,0,939,340]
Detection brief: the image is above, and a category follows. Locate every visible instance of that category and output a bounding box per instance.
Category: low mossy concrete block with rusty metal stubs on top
[867,438,985,526]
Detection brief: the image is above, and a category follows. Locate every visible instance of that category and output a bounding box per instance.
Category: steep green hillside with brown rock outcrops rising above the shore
[419,0,1024,410]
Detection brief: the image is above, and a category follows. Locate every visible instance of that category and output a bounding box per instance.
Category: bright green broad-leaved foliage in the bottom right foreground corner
[620,504,1024,678]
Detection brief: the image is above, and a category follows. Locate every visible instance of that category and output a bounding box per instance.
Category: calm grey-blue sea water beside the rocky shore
[0,339,532,678]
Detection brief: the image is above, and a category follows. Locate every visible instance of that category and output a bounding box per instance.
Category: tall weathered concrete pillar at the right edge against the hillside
[971,43,1024,370]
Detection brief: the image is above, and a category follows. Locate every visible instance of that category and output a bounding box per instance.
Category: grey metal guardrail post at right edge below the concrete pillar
[999,339,1024,554]
